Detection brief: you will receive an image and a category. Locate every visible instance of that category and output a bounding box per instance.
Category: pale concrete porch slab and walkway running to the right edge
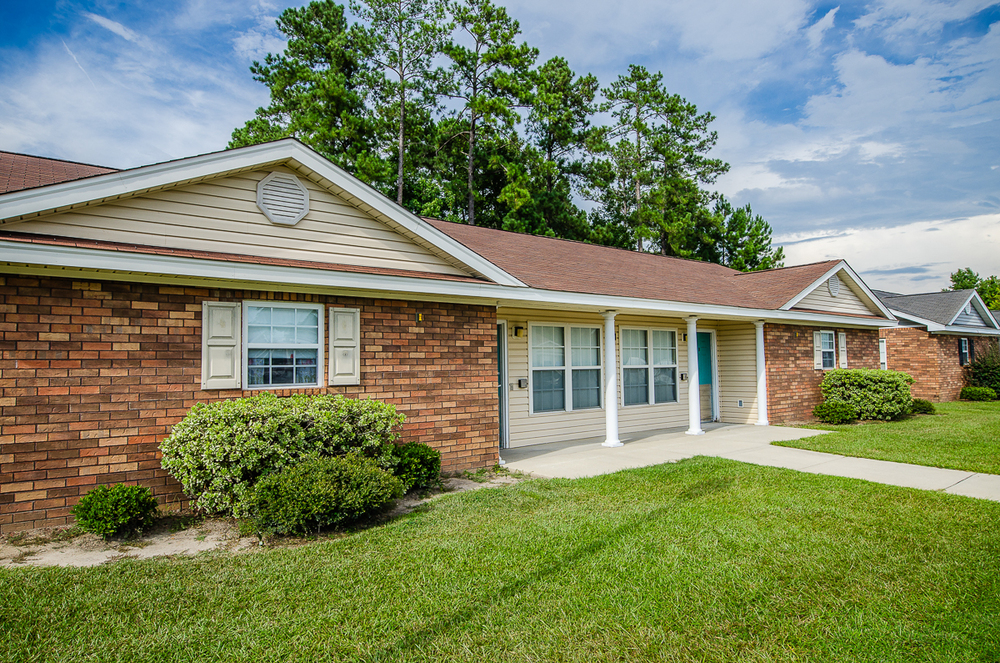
[500,424,1000,502]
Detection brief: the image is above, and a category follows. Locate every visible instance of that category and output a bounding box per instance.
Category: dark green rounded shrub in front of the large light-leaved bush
[245,453,403,534]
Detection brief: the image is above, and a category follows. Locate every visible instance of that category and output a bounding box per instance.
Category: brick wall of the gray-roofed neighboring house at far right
[881,327,996,403]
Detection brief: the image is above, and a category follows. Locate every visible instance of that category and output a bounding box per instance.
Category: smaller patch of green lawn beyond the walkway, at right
[772,401,1000,474]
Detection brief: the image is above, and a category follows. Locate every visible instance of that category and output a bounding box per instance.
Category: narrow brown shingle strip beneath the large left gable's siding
[0,231,491,283]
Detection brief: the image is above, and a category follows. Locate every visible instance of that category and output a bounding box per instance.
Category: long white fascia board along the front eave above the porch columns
[0,240,896,328]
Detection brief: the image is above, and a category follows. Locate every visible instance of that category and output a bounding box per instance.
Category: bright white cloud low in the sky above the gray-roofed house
[775,214,1000,294]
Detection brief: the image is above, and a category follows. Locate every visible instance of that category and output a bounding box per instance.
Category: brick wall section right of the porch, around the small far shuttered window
[764,323,878,424]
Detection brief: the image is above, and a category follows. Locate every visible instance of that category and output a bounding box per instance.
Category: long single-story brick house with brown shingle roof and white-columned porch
[0,139,895,531]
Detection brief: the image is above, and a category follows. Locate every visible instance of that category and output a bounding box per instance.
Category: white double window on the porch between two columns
[621,328,677,405]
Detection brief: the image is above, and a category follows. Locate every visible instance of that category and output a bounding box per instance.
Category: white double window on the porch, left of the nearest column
[530,325,601,413]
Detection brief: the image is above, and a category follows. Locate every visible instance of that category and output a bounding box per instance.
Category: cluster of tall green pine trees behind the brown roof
[229,0,784,278]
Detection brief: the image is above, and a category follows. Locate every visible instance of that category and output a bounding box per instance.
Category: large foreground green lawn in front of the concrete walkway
[0,458,1000,663]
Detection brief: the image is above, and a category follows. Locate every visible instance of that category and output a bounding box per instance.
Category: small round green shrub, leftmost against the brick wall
[70,483,157,539]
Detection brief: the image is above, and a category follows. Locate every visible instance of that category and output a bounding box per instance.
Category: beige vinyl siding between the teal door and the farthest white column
[716,322,757,424]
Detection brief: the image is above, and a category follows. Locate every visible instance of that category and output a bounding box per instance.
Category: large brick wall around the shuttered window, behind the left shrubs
[0,275,498,532]
